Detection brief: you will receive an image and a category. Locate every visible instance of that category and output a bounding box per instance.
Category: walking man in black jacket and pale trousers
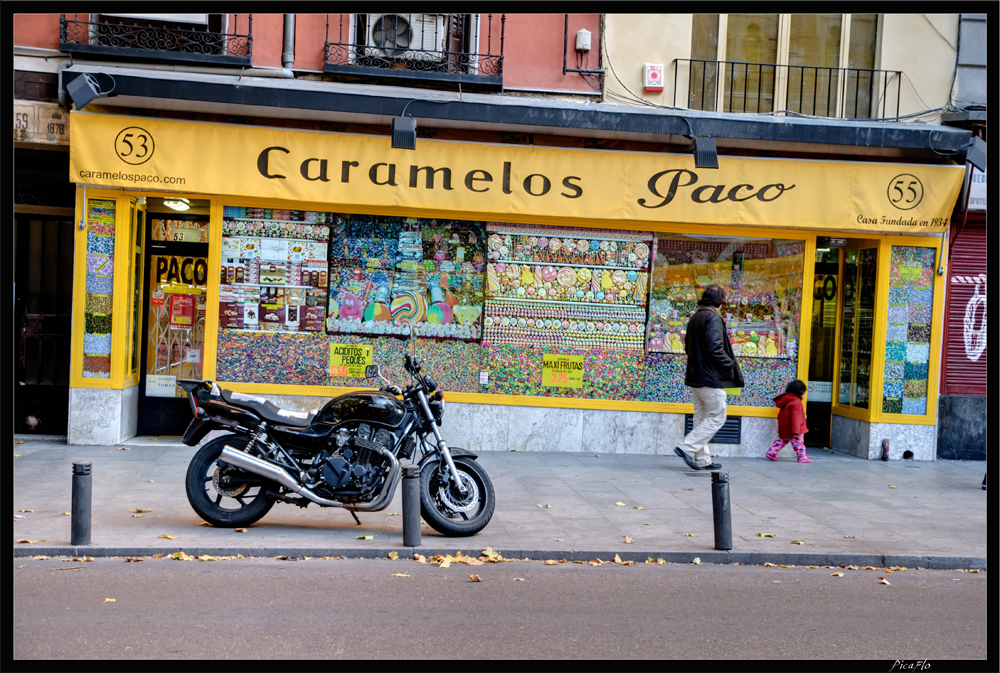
[674,285,744,470]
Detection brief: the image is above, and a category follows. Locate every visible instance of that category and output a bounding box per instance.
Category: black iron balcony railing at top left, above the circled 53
[59,14,253,65]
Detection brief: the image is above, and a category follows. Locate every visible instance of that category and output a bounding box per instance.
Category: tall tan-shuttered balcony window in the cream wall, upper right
[687,14,887,117]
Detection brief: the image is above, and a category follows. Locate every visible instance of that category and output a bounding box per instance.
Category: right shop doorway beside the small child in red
[805,238,878,447]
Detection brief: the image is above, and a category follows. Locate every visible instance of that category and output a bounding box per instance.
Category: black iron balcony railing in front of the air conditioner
[323,14,506,88]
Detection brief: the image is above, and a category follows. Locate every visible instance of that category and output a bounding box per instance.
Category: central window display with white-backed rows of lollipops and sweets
[483,223,653,350]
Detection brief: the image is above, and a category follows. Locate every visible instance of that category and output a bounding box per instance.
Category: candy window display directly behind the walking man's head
[646,234,805,359]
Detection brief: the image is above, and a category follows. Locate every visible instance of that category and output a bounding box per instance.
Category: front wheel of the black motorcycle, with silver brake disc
[420,456,496,537]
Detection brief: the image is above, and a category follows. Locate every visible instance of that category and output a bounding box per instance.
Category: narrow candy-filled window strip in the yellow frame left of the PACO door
[83,199,116,379]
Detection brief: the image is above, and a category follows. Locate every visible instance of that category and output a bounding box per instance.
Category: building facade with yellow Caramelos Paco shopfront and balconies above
[17,14,984,459]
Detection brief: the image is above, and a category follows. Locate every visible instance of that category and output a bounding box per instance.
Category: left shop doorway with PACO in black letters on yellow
[137,198,209,436]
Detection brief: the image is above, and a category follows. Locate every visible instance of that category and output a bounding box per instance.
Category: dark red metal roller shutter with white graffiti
[941,225,988,395]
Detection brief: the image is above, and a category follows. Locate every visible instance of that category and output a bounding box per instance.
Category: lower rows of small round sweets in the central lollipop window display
[483,301,646,350]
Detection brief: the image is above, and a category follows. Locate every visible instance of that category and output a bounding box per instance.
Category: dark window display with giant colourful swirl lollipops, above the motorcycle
[327,214,485,340]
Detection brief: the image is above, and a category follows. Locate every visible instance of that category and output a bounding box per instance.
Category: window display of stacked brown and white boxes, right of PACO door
[219,206,334,333]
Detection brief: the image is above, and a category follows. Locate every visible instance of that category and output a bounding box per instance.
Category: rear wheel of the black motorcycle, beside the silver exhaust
[185,435,277,528]
